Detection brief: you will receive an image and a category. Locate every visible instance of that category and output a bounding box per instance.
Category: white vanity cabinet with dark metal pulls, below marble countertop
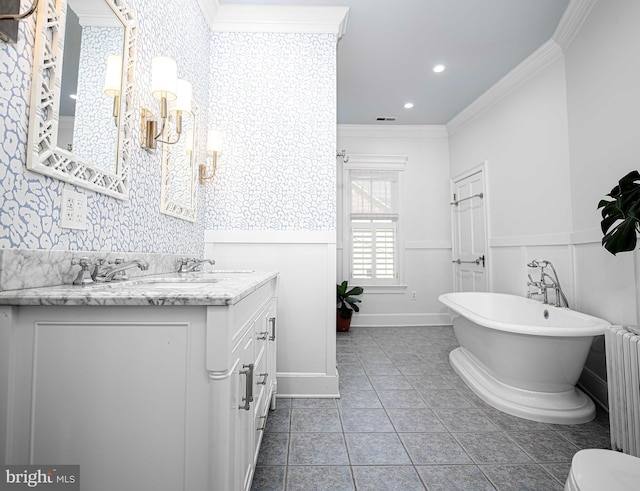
[0,275,277,491]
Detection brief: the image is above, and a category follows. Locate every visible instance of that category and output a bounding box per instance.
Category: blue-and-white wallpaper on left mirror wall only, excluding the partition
[0,0,206,255]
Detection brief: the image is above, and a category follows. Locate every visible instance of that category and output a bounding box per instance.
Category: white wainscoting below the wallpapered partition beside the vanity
[205,230,339,397]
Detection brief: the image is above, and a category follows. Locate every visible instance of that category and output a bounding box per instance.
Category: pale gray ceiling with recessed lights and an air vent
[220,0,569,125]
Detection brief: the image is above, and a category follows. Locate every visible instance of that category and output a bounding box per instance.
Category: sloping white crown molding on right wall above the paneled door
[447,39,562,135]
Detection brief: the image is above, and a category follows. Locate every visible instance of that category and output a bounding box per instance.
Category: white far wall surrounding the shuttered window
[337,125,452,326]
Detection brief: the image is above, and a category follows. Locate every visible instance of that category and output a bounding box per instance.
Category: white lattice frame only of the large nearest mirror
[27,0,137,199]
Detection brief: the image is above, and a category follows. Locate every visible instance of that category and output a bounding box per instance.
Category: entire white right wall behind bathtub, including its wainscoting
[449,0,640,403]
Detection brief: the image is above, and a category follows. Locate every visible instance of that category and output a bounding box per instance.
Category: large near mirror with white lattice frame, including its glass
[27,0,136,199]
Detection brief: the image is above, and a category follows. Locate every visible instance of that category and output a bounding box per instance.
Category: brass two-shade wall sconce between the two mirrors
[140,56,192,149]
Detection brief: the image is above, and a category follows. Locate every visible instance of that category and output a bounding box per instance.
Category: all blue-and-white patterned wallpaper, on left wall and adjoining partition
[0,0,336,255]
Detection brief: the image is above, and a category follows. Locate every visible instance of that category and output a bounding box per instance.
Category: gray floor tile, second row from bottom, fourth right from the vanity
[399,433,473,465]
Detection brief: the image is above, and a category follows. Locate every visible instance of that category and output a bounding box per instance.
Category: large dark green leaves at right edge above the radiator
[598,170,640,256]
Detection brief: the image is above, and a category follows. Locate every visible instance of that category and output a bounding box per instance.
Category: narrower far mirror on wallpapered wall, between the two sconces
[160,101,198,222]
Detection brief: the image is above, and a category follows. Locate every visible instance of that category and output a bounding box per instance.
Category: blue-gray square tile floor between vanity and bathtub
[252,327,610,491]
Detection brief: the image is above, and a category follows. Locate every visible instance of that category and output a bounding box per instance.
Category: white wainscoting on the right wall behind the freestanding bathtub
[490,229,640,407]
